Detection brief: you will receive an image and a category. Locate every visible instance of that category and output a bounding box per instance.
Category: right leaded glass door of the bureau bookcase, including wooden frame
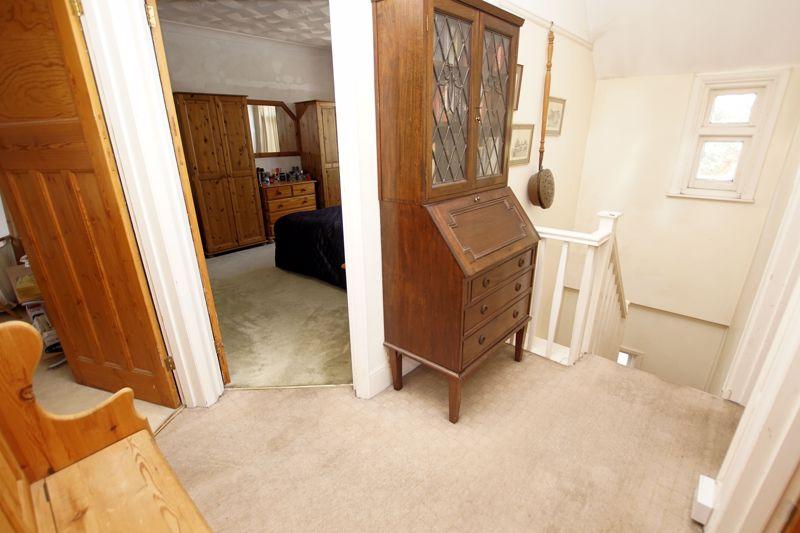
[474,14,518,188]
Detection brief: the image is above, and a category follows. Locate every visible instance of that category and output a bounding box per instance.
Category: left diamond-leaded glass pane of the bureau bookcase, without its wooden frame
[432,13,472,185]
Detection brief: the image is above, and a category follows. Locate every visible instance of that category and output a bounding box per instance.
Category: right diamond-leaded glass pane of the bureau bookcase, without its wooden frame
[476,30,511,178]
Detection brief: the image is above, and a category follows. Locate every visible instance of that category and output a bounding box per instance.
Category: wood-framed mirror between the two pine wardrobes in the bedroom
[247,100,300,157]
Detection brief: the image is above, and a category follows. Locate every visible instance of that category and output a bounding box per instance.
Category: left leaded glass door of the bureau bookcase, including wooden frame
[427,0,479,198]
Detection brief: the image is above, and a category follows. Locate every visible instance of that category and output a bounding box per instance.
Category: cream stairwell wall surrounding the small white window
[575,68,800,392]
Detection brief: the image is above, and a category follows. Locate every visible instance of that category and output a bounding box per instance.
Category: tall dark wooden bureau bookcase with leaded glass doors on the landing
[374,0,539,423]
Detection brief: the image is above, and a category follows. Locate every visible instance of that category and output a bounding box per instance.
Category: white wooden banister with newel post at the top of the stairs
[528,211,628,365]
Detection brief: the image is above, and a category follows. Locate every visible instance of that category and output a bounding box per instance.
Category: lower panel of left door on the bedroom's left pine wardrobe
[199,178,237,253]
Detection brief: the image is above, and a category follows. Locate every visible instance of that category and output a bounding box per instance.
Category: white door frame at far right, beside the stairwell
[706,157,800,532]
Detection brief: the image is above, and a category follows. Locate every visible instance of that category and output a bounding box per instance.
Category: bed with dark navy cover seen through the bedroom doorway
[275,206,347,289]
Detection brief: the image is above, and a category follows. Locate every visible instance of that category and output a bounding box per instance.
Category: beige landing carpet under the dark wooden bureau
[157,347,741,532]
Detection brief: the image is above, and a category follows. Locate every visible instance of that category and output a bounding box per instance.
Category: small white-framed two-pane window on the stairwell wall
[669,70,788,202]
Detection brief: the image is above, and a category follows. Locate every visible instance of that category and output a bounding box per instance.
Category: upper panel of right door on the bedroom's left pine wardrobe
[214,96,256,177]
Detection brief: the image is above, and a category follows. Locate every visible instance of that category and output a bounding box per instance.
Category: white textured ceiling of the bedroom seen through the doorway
[158,0,331,46]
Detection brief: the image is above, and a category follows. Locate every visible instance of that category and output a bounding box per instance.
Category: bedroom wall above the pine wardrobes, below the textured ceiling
[163,22,333,107]
